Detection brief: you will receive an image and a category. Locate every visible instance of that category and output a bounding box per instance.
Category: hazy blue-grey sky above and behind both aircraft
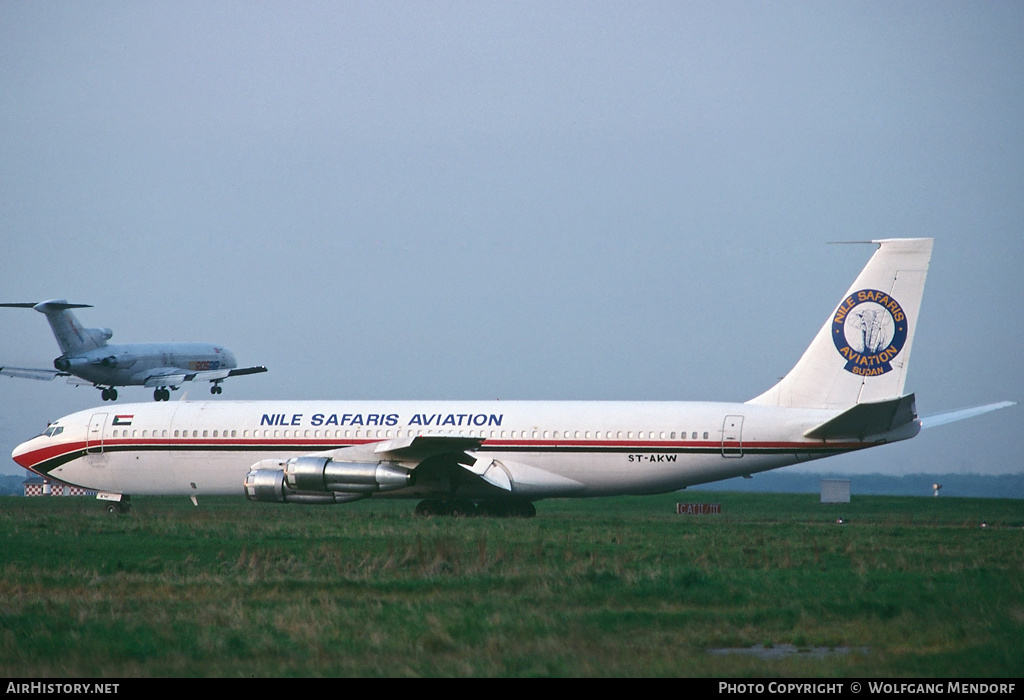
[0,0,1024,474]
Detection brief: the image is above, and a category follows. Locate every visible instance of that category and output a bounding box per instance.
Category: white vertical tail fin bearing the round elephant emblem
[749,238,933,409]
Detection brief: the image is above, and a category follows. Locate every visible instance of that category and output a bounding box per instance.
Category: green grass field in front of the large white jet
[0,492,1024,677]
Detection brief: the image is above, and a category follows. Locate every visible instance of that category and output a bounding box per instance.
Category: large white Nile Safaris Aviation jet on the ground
[13,238,1011,516]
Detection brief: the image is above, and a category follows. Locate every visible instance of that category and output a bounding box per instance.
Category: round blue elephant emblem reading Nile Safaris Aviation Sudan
[833,290,907,377]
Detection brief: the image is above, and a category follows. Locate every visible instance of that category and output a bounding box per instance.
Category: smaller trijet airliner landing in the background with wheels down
[0,299,266,401]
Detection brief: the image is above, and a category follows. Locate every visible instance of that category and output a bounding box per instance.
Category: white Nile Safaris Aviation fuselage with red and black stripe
[13,400,905,499]
